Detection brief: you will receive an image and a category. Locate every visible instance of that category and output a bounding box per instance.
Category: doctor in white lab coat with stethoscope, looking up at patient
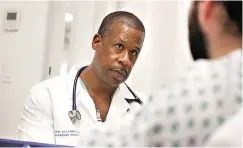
[18,11,145,146]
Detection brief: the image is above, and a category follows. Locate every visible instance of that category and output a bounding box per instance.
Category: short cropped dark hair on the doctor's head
[98,11,145,36]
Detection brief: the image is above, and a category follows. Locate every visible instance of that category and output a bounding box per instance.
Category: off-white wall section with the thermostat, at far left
[0,1,49,139]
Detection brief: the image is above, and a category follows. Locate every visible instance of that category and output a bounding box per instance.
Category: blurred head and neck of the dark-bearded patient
[189,1,242,60]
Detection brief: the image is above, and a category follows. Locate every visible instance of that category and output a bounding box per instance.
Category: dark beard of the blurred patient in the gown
[189,2,208,60]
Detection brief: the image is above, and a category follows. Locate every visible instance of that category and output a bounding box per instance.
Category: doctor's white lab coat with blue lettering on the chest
[18,66,147,146]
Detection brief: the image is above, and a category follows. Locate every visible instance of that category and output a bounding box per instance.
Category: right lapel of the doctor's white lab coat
[106,84,130,122]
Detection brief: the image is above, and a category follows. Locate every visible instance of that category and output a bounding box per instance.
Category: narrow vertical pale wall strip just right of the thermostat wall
[45,1,68,78]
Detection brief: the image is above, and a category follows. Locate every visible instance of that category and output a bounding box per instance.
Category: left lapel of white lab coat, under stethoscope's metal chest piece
[68,66,97,121]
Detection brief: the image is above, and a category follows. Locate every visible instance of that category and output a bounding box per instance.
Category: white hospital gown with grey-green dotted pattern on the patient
[79,49,242,147]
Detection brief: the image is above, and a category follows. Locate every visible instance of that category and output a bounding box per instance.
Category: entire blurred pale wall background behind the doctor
[0,0,192,139]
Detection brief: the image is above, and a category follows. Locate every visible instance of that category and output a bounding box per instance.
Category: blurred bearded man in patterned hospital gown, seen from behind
[80,0,242,147]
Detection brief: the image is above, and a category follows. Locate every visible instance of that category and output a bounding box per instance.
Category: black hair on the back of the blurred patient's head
[222,1,242,33]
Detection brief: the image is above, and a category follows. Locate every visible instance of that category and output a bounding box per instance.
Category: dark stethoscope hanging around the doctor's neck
[68,66,143,124]
